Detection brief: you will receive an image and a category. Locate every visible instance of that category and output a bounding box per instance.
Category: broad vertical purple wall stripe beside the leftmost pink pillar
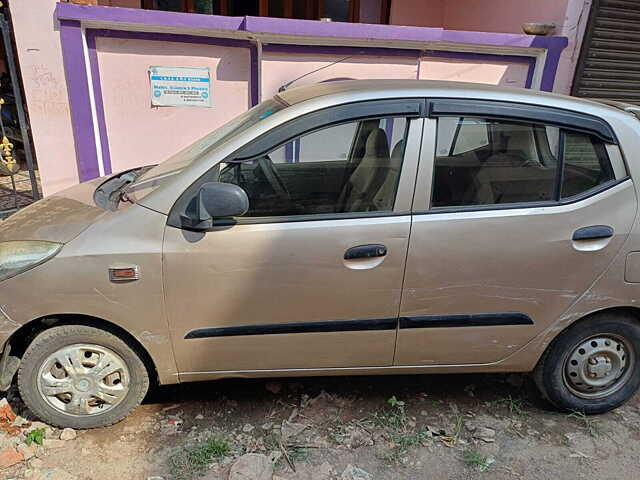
[60,20,100,182]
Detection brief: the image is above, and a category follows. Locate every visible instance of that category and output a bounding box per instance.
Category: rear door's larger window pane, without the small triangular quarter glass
[432,117,557,207]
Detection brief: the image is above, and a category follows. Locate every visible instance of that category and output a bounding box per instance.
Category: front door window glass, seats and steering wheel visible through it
[220,117,408,217]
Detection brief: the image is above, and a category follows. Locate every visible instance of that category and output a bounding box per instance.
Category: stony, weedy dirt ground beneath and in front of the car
[0,375,640,480]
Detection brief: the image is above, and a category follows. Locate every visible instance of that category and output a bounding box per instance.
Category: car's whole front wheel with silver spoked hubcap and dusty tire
[18,325,149,428]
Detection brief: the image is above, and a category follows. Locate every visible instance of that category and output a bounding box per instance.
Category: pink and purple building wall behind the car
[10,0,591,195]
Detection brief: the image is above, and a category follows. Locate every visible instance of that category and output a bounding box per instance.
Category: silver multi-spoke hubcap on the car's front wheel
[38,344,130,416]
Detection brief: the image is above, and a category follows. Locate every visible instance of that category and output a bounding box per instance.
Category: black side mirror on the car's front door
[180,182,249,230]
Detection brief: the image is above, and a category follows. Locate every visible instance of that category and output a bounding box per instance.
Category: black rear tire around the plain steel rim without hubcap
[533,313,640,414]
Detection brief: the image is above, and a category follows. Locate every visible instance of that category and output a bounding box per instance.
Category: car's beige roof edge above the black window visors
[276,80,629,118]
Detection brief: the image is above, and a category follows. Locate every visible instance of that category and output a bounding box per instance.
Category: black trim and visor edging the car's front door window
[167,97,427,229]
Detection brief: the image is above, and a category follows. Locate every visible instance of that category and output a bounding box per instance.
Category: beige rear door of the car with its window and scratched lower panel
[395,109,636,365]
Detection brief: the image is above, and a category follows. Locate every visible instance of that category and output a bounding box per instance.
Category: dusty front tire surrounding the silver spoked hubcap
[18,325,149,429]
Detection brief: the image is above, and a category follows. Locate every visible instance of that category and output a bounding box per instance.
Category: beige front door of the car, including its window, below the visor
[164,110,423,379]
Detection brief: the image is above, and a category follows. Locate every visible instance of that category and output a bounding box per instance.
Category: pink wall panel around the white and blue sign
[96,37,250,172]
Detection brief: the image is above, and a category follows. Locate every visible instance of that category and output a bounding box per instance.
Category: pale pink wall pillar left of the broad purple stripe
[11,0,78,195]
